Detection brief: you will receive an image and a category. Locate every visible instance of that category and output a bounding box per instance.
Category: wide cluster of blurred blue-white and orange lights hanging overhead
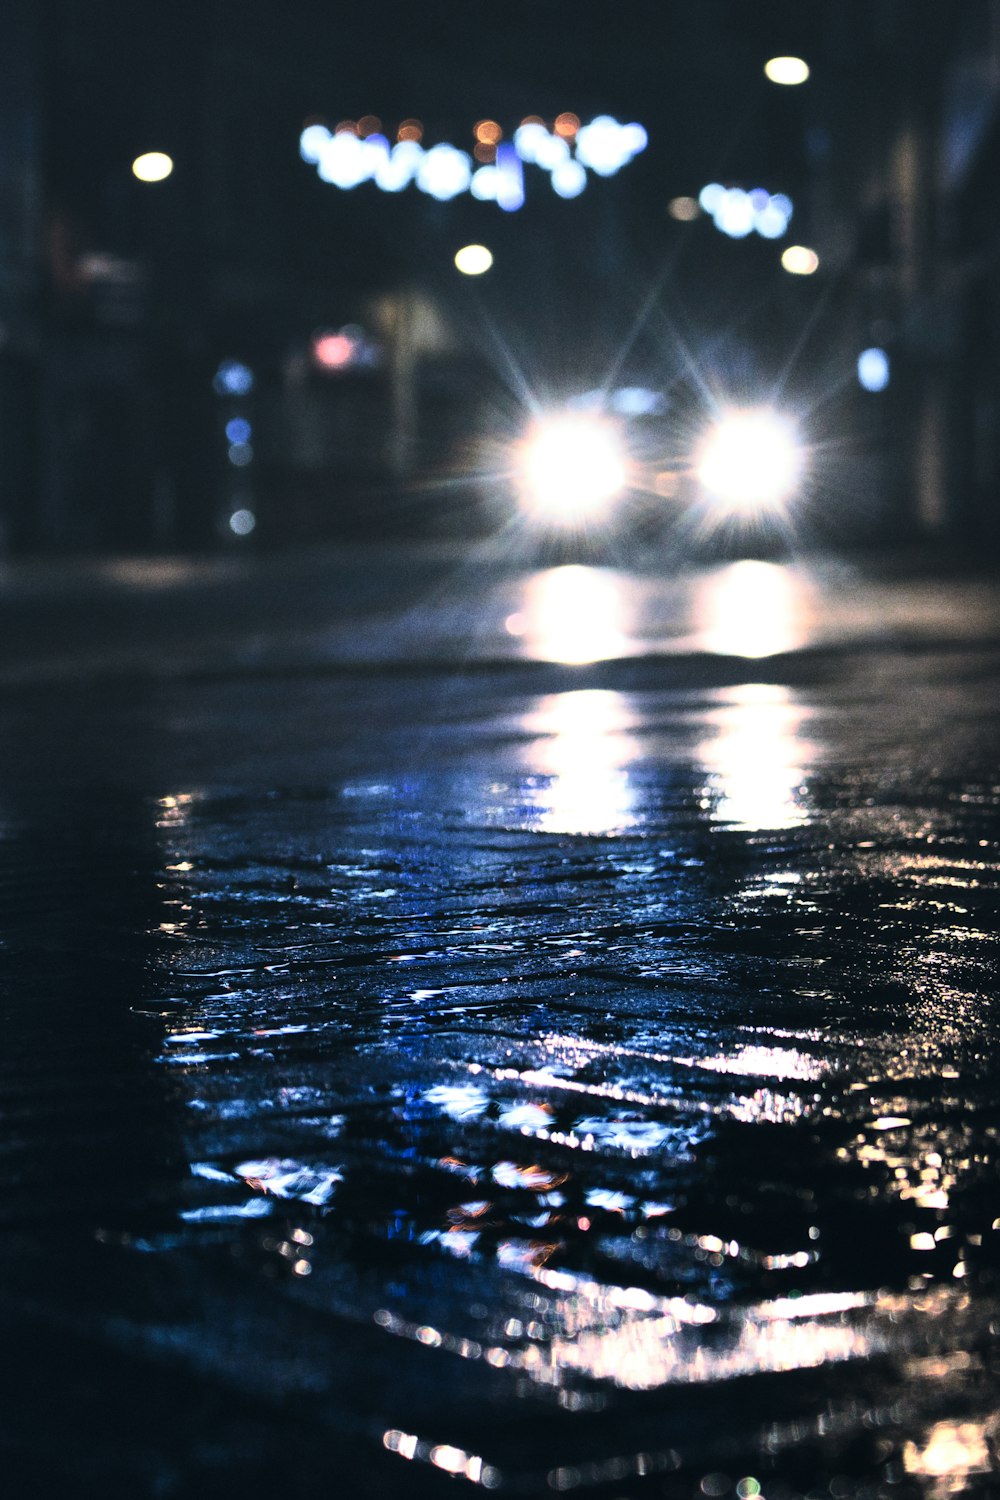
[298,114,648,213]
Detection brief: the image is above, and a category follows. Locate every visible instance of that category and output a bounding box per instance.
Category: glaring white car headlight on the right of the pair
[696,410,802,516]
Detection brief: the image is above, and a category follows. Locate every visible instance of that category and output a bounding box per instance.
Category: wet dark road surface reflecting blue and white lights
[0,552,1000,1500]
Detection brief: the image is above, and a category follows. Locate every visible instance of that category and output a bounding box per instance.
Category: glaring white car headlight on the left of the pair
[520,413,628,527]
